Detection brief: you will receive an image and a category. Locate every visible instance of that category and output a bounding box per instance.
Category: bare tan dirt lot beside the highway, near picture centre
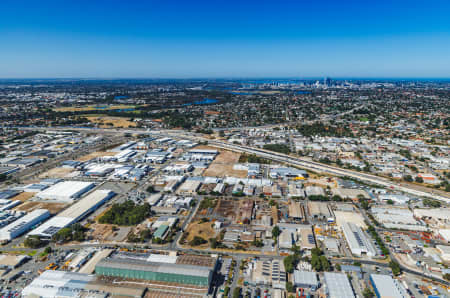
[203,150,247,178]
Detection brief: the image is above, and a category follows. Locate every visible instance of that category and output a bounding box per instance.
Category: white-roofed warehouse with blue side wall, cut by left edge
[0,209,50,242]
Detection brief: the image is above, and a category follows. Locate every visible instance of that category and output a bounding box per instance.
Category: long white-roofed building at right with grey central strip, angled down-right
[342,222,377,257]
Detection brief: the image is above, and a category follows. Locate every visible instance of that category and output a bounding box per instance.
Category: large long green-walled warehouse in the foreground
[95,255,217,287]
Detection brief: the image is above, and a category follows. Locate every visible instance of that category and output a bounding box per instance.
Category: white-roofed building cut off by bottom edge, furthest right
[370,274,410,298]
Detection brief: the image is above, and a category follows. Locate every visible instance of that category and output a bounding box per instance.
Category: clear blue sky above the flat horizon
[0,0,450,78]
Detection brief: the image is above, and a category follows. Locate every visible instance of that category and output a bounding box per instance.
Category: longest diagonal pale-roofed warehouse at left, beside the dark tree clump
[29,190,115,239]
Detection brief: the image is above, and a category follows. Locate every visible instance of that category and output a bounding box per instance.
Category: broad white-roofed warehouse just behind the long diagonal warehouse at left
[37,181,95,202]
